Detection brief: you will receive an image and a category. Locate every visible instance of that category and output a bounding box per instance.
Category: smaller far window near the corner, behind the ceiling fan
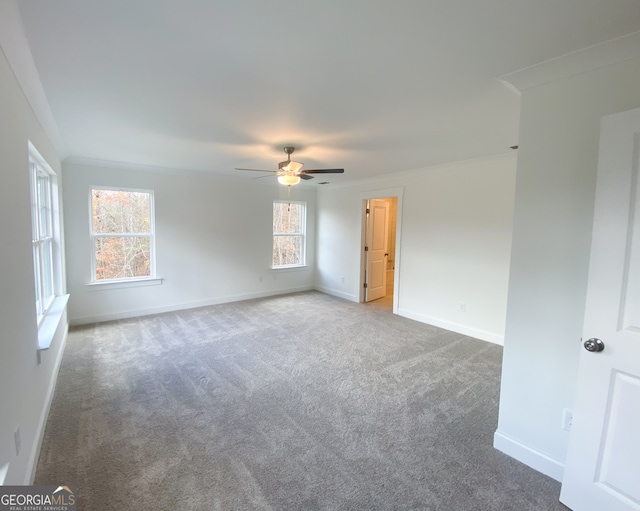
[273,201,306,268]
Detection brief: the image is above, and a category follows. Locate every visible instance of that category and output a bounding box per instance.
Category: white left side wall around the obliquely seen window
[0,44,67,484]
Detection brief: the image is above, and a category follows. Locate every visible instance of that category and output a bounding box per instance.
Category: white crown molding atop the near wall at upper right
[498,31,640,92]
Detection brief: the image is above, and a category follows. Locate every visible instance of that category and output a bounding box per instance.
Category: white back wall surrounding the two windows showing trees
[64,162,315,324]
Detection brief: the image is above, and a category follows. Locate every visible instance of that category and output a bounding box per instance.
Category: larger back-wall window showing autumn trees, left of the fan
[91,188,155,282]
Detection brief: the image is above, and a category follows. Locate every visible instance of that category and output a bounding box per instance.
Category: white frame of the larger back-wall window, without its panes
[89,185,159,289]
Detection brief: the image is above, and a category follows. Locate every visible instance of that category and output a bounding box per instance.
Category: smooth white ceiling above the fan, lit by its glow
[11,0,640,183]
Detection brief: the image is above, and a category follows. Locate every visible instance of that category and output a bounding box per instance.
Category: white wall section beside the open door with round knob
[495,60,640,479]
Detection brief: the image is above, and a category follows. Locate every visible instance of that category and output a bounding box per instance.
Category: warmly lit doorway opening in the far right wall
[360,195,398,312]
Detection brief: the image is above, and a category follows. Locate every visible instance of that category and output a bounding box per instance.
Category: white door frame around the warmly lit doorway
[358,186,404,314]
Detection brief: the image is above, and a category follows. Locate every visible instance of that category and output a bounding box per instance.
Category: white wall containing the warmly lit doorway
[316,154,516,343]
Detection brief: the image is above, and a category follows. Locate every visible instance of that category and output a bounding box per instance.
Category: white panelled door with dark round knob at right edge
[560,109,640,511]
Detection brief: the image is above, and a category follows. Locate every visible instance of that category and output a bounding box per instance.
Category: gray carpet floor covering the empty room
[36,292,567,511]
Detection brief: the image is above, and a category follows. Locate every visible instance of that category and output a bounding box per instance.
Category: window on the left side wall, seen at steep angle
[29,158,55,321]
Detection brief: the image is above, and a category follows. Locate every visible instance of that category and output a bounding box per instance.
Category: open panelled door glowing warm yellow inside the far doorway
[365,199,389,302]
